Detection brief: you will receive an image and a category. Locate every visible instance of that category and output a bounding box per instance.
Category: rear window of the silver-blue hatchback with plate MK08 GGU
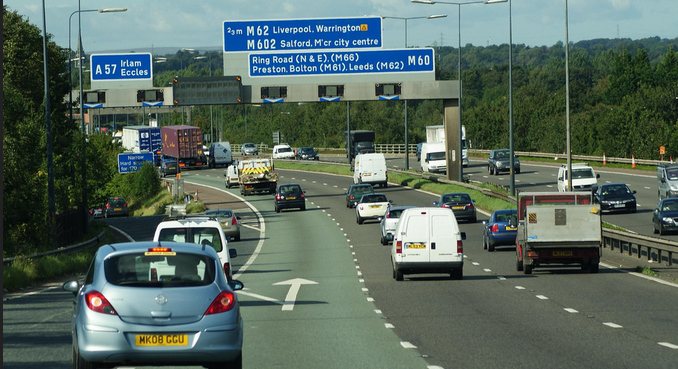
[104,252,217,287]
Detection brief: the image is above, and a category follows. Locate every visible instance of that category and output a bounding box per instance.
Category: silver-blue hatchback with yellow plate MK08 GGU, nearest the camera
[63,242,243,368]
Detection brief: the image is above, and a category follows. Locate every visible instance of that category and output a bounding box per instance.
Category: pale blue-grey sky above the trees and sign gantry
[3,0,678,54]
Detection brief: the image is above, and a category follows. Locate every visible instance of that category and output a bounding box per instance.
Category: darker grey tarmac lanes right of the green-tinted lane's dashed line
[272,170,678,368]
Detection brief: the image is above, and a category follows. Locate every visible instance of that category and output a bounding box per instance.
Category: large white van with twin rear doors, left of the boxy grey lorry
[387,207,466,281]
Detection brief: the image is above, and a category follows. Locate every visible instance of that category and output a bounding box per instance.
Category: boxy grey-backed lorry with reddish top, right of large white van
[509,192,602,274]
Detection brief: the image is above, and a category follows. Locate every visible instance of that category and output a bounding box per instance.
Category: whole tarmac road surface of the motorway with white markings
[5,159,678,368]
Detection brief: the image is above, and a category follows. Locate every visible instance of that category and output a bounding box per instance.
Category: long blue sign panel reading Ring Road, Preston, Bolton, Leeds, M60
[249,48,435,77]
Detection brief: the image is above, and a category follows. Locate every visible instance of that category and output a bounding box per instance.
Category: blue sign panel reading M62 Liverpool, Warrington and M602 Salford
[224,17,382,52]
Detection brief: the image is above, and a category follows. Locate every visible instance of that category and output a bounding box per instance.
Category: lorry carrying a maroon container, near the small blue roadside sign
[160,125,207,168]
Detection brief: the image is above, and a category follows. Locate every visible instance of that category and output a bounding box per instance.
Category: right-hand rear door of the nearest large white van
[429,209,463,262]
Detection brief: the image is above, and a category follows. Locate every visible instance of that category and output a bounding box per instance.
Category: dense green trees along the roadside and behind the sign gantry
[3,6,678,256]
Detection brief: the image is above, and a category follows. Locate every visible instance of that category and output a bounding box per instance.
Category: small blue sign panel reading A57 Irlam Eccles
[90,53,153,81]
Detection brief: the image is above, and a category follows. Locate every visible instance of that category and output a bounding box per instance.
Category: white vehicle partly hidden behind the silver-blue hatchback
[153,215,238,281]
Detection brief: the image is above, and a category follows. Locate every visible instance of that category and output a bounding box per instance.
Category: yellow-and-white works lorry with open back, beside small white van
[238,158,278,196]
